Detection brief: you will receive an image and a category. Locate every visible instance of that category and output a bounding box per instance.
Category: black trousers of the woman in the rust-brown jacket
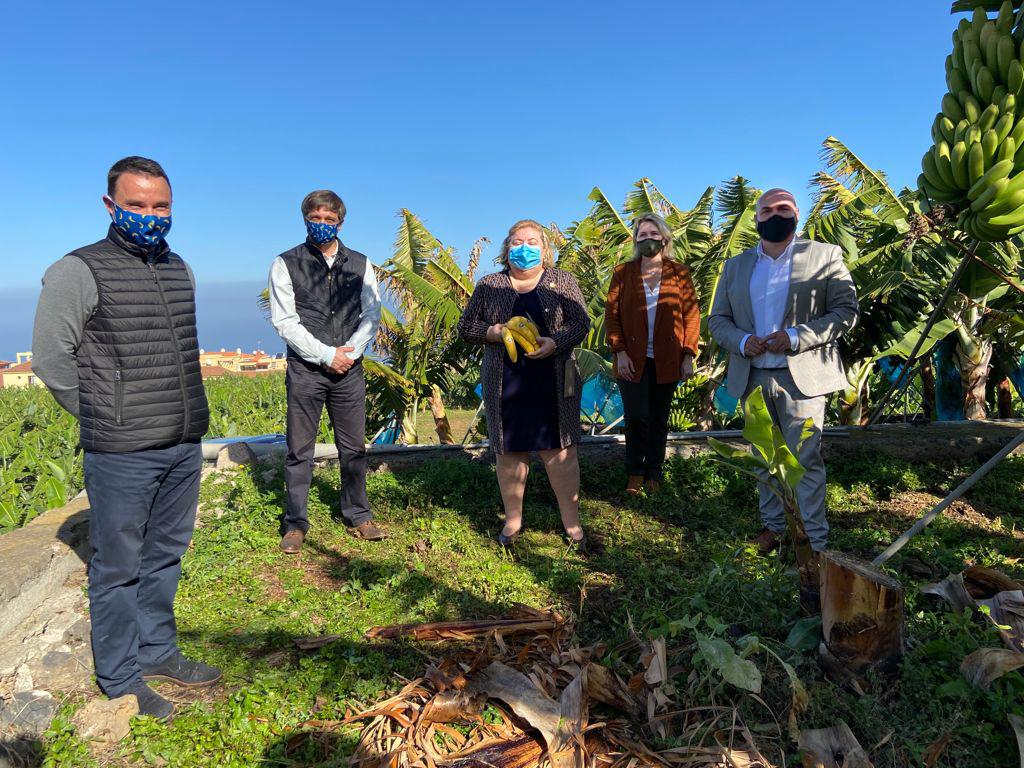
[618,357,678,480]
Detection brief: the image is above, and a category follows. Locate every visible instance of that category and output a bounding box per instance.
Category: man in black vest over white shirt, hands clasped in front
[269,189,386,555]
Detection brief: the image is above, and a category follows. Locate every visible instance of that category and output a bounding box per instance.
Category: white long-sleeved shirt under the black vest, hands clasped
[270,246,381,366]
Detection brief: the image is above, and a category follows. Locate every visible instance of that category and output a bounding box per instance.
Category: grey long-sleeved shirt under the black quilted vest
[32,255,196,417]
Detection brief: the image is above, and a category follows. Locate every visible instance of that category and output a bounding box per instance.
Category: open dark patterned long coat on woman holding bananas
[459,267,590,454]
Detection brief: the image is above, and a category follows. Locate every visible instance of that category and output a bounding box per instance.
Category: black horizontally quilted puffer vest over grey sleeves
[72,226,210,453]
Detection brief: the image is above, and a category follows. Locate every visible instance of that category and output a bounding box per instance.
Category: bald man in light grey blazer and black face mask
[708,189,859,554]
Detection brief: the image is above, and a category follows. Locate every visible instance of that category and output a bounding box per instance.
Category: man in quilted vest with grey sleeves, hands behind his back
[32,157,220,719]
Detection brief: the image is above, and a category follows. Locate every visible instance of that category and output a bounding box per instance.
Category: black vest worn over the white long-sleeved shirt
[281,241,367,359]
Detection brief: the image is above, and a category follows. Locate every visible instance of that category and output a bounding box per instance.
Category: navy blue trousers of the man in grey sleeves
[85,443,203,697]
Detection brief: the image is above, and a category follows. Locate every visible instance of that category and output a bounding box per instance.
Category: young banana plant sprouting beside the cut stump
[708,387,818,611]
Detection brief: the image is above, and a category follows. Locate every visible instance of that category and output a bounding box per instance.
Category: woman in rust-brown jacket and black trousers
[604,213,700,494]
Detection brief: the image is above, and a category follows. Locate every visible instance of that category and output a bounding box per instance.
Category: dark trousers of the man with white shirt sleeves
[284,359,373,532]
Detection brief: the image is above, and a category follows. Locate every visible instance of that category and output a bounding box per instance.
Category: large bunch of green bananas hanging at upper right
[918,1,1024,242]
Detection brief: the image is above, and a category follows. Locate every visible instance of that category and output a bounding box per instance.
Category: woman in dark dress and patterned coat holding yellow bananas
[459,219,590,551]
